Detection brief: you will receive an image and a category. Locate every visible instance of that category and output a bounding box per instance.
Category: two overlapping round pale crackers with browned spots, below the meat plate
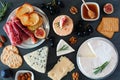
[0,45,22,69]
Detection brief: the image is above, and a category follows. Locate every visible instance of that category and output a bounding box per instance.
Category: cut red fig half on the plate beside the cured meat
[34,27,46,39]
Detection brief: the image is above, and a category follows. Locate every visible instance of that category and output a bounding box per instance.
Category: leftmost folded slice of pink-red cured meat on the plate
[3,21,22,46]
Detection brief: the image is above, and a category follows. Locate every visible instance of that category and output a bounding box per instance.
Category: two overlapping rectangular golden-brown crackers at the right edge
[97,17,119,38]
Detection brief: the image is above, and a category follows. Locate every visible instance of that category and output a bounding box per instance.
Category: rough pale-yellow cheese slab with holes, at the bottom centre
[48,56,75,80]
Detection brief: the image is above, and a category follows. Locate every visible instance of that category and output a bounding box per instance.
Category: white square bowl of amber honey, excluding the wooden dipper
[81,2,100,21]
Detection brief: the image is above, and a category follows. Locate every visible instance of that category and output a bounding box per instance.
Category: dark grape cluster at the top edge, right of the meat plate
[40,0,64,15]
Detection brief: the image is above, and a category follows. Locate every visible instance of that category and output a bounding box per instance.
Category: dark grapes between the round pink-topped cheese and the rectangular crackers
[75,23,94,37]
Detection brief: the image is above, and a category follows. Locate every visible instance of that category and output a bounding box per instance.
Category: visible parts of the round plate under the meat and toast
[7,6,50,49]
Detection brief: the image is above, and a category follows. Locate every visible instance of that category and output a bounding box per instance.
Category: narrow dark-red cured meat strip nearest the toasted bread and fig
[15,20,38,44]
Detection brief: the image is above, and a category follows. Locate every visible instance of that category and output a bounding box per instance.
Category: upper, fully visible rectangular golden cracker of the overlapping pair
[102,17,119,32]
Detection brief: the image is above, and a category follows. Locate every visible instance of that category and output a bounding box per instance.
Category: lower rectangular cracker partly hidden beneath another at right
[97,21,114,38]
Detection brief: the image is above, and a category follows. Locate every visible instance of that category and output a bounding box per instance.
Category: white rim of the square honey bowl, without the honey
[81,2,100,21]
